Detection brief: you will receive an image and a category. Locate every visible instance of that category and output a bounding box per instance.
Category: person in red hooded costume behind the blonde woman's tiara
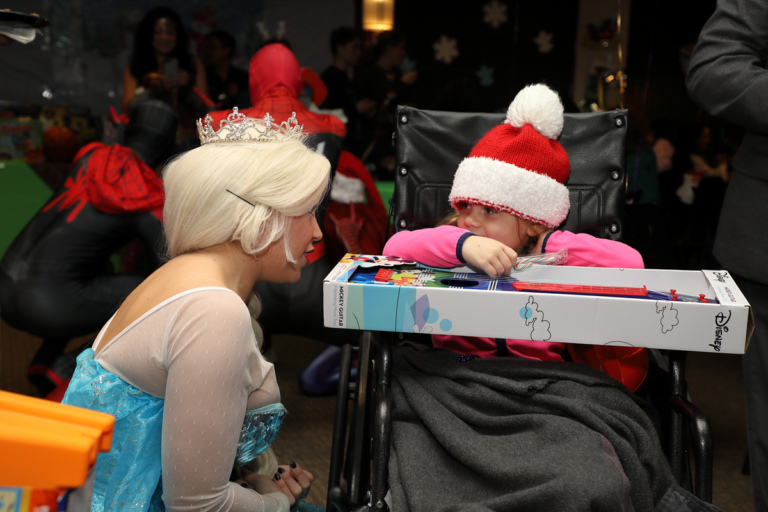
[209,42,356,356]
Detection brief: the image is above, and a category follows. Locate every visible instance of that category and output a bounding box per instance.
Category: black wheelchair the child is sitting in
[327,106,712,512]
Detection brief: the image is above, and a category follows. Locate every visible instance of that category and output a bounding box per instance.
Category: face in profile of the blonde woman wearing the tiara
[263,210,323,283]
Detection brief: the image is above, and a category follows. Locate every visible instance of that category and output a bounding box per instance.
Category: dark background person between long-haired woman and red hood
[203,29,251,109]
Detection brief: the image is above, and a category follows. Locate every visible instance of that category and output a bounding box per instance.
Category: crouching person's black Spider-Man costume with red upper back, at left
[0,101,176,393]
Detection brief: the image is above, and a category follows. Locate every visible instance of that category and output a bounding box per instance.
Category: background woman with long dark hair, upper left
[122,6,213,153]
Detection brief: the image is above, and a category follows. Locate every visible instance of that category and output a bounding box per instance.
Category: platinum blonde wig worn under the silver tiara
[163,140,330,263]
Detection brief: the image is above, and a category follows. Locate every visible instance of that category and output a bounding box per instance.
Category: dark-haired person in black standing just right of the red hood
[320,27,377,157]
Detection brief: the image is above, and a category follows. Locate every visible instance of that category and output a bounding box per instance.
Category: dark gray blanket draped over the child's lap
[389,346,679,512]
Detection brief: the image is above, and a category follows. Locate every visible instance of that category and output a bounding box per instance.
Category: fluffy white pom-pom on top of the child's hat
[507,84,563,139]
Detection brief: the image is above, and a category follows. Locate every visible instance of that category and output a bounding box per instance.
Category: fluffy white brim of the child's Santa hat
[448,157,571,229]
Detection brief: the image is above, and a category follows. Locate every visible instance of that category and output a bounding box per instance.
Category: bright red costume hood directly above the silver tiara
[248,43,301,105]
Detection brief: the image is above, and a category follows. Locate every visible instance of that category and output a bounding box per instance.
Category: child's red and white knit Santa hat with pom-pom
[448,84,571,228]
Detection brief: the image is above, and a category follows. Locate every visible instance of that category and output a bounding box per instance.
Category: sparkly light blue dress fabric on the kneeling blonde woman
[62,348,285,512]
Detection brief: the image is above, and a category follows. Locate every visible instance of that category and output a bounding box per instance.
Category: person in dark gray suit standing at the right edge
[686,0,768,512]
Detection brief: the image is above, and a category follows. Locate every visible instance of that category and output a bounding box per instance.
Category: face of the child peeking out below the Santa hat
[457,203,539,253]
